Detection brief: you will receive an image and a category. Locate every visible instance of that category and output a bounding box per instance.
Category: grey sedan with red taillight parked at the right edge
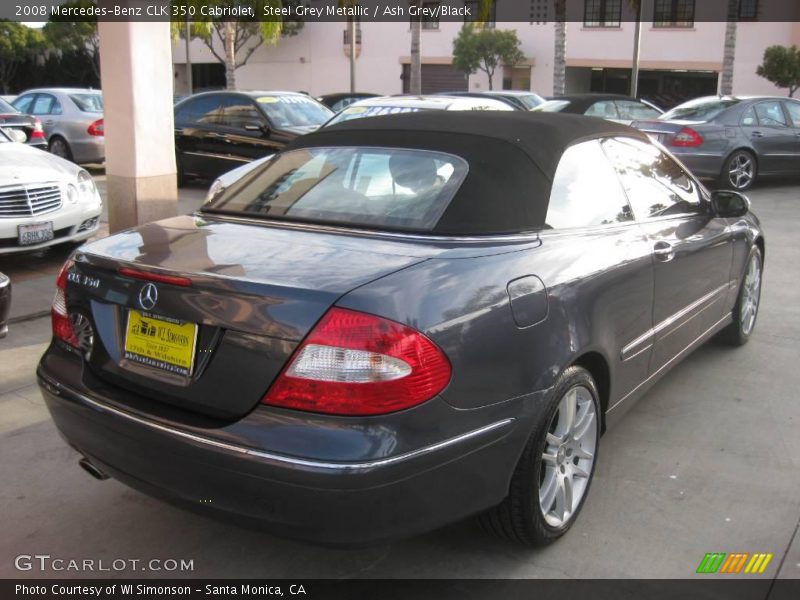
[634,96,800,190]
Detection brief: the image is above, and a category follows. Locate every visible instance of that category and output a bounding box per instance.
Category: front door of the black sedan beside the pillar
[216,94,285,169]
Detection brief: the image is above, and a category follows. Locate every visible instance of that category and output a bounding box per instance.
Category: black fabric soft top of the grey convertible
[287,111,647,235]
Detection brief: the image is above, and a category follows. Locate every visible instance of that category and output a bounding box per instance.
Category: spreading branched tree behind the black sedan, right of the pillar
[172,0,303,90]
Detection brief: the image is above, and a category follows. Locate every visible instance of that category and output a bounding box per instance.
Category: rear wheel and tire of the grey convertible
[478,366,600,546]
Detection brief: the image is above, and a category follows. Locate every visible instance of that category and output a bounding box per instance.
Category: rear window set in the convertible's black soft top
[203,147,468,231]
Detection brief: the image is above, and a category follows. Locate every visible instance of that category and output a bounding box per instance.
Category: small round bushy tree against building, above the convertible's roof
[453,24,525,90]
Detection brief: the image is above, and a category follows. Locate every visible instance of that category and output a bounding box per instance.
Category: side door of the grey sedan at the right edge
[742,100,797,173]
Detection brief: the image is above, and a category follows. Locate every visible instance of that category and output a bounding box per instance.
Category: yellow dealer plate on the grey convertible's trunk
[125,310,197,375]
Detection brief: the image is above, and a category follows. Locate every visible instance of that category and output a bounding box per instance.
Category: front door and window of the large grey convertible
[604,138,733,374]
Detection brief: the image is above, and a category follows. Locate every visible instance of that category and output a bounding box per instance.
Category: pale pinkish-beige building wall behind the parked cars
[173,22,800,95]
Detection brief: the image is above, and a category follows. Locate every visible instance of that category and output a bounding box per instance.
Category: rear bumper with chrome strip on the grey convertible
[38,350,529,545]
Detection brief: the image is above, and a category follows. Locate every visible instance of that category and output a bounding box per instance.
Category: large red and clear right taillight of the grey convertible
[262,308,451,415]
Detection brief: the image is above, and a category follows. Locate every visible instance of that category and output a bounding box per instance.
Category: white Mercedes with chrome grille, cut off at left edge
[0,129,103,254]
